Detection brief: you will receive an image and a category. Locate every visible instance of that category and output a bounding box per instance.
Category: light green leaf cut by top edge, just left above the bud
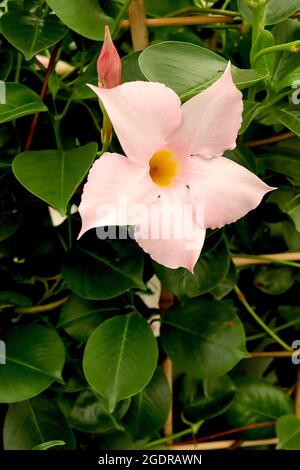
[46,0,114,41]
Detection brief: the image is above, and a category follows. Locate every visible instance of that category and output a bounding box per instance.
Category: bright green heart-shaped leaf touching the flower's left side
[13,142,97,215]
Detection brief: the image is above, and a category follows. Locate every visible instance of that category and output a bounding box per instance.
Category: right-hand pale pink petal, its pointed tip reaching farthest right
[187,156,275,228]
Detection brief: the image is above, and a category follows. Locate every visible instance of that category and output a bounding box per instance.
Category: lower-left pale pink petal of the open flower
[78,152,158,237]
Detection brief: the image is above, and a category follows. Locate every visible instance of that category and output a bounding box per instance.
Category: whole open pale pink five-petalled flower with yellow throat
[79,64,273,271]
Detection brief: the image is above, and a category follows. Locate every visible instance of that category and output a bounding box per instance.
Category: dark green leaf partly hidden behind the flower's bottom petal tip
[154,232,230,299]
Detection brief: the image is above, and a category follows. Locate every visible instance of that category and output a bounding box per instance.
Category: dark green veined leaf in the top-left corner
[0,0,68,60]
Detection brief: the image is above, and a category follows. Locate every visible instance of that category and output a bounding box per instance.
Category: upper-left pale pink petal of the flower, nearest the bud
[88,81,182,165]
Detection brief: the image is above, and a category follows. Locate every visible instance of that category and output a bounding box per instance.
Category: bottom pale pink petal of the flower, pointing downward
[134,188,205,272]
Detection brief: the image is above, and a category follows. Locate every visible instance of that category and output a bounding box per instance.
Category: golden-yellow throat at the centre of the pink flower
[149,149,178,186]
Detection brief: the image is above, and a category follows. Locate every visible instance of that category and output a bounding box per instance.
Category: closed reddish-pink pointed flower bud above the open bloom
[97,26,122,88]
